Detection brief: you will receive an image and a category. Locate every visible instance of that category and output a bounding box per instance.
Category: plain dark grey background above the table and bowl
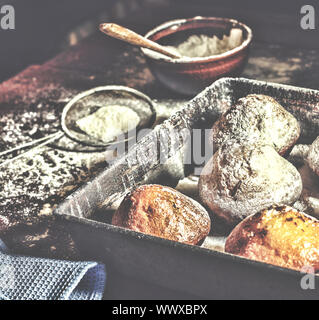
[0,0,319,81]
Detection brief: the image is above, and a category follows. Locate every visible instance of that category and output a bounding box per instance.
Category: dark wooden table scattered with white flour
[0,26,319,299]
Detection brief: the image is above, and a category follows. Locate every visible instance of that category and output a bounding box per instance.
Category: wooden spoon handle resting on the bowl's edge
[100,23,181,59]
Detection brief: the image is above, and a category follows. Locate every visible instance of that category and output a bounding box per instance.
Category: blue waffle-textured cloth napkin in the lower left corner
[0,240,106,300]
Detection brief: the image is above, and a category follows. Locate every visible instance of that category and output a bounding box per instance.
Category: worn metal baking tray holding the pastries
[55,78,319,299]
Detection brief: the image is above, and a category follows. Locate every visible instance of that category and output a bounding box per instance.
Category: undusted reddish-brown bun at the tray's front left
[112,185,210,244]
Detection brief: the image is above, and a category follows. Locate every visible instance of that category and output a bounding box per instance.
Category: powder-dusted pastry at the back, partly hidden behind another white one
[210,94,300,155]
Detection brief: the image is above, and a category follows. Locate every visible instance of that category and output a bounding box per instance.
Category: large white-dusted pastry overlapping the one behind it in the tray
[199,140,302,225]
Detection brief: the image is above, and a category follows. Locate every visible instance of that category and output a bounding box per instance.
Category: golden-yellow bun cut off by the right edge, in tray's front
[225,206,319,272]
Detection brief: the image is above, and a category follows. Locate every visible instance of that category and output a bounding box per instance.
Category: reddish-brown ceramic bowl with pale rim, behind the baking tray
[141,17,252,95]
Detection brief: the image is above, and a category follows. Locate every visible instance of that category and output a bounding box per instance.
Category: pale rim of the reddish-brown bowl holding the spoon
[140,16,253,64]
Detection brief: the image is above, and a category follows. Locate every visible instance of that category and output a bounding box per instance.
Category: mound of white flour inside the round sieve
[76,106,140,143]
